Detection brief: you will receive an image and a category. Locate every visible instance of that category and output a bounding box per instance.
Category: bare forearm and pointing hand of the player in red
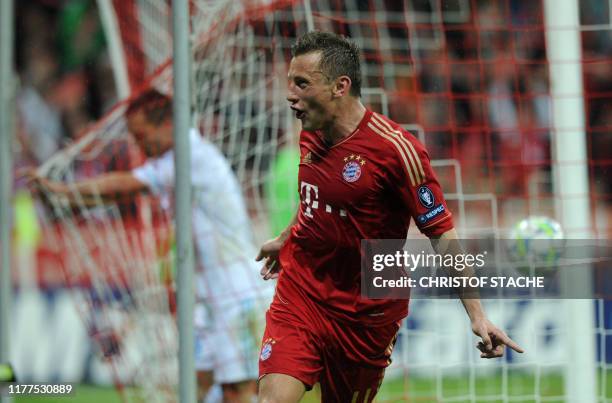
[430,228,524,358]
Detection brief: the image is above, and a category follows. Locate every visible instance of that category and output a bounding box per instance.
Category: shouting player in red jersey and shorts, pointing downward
[257,32,522,403]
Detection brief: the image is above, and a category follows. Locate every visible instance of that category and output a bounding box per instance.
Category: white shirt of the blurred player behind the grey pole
[132,129,262,299]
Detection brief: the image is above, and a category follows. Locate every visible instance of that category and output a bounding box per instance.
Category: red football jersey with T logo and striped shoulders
[279,110,453,325]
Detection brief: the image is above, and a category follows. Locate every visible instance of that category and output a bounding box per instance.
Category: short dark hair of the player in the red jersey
[291,31,361,97]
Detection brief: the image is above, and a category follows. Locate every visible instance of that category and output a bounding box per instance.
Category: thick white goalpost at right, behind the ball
[544,0,597,403]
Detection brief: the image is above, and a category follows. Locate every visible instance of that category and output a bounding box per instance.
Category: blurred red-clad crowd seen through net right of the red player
[384,0,612,203]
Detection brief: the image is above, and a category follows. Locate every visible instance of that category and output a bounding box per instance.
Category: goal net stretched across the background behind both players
[35,0,612,402]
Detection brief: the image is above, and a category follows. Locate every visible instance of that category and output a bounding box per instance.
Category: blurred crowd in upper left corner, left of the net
[15,0,116,178]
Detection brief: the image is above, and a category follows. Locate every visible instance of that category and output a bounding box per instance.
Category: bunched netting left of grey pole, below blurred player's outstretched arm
[40,105,178,402]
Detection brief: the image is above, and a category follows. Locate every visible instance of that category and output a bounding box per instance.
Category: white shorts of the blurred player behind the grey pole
[195,298,270,384]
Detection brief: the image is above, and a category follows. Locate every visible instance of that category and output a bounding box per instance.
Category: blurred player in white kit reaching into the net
[28,90,272,403]
